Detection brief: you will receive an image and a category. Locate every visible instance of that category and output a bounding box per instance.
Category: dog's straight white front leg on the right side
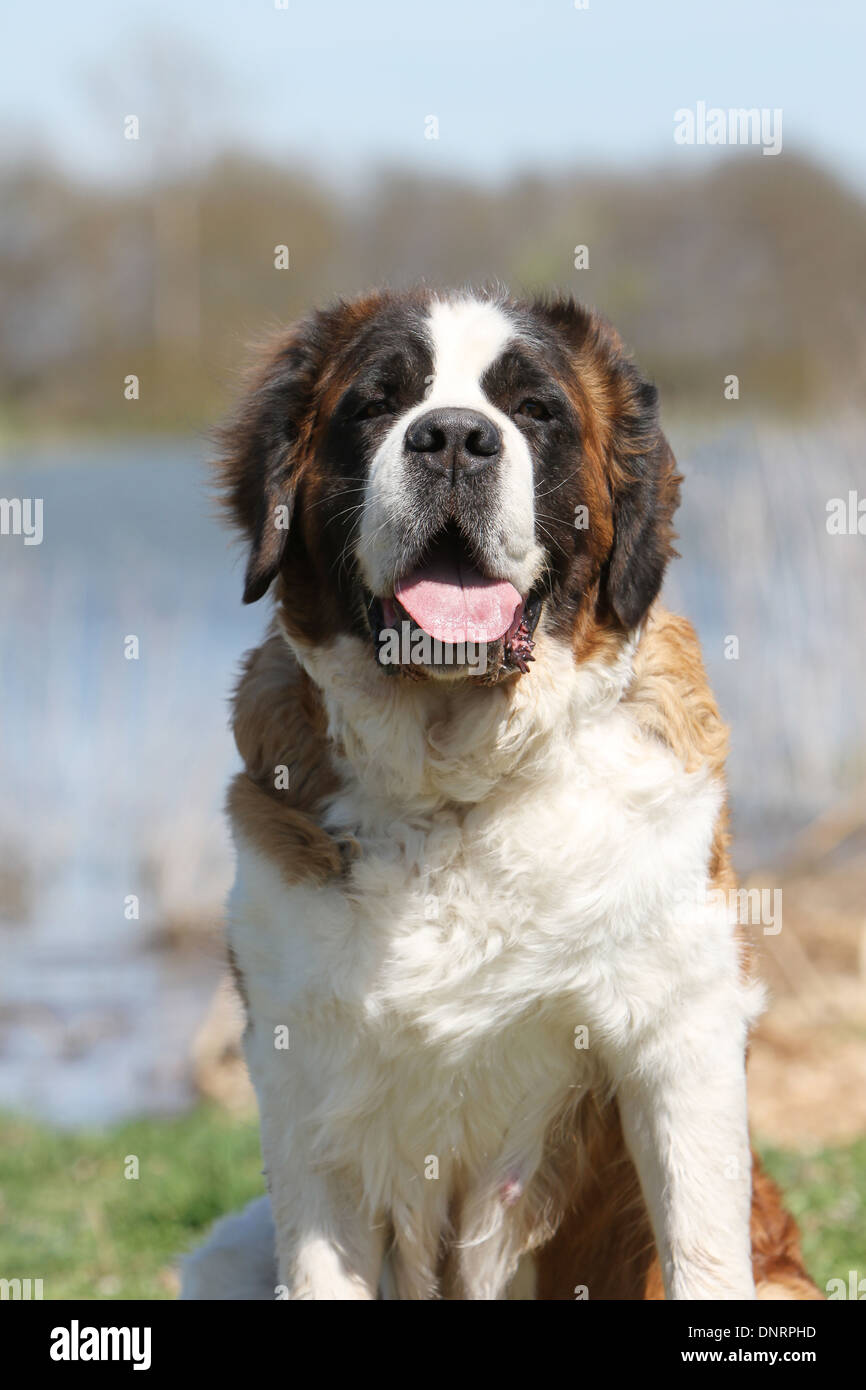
[617,998,755,1298]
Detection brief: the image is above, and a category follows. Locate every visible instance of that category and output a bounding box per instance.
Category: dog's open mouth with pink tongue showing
[367,525,542,680]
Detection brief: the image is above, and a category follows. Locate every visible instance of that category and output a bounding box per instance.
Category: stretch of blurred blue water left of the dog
[0,442,267,1122]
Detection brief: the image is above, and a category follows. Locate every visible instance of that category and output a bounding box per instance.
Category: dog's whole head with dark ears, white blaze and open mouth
[222,292,678,682]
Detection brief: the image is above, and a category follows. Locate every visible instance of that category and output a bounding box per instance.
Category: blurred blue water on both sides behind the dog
[0,421,866,1123]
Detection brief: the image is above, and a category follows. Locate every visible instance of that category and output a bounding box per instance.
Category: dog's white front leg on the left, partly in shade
[247,1036,385,1301]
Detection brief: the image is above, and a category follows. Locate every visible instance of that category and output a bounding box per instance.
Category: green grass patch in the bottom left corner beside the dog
[0,1106,264,1300]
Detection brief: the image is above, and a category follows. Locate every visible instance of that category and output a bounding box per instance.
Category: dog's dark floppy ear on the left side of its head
[217,320,320,603]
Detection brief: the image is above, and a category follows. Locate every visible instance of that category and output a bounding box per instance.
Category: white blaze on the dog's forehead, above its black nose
[425,299,514,406]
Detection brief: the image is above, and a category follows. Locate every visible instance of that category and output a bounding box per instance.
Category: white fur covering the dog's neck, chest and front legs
[207,622,758,1298]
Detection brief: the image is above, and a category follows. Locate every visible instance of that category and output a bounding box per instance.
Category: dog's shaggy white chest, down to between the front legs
[229,700,719,1250]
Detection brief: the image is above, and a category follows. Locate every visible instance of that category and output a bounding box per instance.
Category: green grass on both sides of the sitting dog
[0,1106,866,1300]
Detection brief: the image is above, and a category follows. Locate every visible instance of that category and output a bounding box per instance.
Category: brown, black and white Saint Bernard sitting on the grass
[182,289,819,1300]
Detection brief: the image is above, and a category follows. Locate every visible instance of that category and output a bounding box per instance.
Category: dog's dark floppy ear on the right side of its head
[602,363,681,631]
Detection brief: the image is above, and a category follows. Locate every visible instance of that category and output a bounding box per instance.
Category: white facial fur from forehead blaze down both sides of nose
[357,297,544,595]
